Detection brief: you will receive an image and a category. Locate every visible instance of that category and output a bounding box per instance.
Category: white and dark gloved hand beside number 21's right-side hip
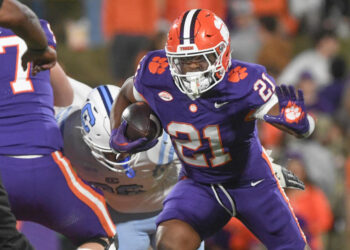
[272,163,305,190]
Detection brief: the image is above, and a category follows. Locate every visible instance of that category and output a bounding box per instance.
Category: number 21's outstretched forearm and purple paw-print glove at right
[253,85,315,138]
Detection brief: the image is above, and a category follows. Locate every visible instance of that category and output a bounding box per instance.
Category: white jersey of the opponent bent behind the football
[56,106,181,213]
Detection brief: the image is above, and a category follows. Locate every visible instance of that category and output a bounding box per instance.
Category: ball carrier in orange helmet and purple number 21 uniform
[110,9,315,250]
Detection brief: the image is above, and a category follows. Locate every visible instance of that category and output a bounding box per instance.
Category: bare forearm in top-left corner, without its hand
[0,0,47,50]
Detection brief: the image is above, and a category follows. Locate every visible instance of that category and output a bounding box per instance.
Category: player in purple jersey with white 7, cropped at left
[0,17,115,249]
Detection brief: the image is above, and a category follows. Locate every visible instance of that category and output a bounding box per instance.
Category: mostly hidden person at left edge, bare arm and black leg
[0,0,56,250]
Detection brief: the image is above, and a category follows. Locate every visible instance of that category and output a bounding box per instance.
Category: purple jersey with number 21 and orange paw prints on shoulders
[134,50,275,183]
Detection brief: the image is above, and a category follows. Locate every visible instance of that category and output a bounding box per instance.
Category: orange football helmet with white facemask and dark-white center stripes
[165,9,231,99]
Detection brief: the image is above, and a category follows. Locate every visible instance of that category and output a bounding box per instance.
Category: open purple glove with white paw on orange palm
[264,85,310,137]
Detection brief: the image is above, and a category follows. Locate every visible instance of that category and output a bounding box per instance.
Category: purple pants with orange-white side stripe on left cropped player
[0,151,115,245]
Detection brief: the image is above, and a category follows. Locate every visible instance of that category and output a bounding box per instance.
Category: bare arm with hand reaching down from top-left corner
[0,0,57,75]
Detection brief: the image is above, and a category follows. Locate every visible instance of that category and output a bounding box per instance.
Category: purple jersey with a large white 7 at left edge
[0,20,62,155]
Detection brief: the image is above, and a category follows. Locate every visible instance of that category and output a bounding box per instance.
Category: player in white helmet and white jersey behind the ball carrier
[56,79,303,250]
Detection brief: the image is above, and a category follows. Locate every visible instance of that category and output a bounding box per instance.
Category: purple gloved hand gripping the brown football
[109,121,158,154]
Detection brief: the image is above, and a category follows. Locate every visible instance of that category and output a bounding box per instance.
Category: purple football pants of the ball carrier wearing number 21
[157,157,306,250]
